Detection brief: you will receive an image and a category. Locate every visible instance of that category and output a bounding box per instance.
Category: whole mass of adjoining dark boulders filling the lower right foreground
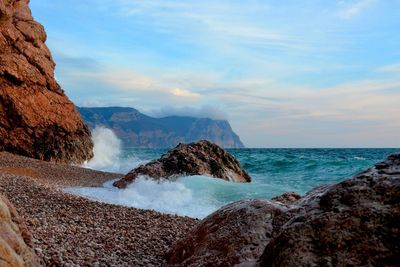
[168,154,400,266]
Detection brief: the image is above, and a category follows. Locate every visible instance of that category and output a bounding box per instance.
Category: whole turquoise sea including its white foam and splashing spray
[65,129,400,219]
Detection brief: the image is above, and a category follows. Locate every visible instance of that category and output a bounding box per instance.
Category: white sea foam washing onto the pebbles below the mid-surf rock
[65,177,222,219]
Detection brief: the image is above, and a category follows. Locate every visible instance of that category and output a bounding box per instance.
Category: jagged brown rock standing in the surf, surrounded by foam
[114,140,251,188]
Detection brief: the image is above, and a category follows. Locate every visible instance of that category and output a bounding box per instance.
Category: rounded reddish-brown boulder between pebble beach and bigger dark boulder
[168,200,286,266]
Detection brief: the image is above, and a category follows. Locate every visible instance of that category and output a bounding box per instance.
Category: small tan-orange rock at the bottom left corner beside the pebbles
[0,195,40,267]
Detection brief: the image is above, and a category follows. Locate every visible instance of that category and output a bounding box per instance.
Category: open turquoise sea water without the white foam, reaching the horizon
[124,148,400,197]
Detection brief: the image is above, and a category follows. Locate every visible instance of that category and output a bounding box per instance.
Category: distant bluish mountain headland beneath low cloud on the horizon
[78,107,244,148]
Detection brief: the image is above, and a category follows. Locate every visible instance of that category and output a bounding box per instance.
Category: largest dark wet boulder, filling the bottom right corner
[260,154,400,266]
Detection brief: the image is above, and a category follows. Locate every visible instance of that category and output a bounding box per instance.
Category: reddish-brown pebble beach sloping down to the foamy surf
[0,152,197,266]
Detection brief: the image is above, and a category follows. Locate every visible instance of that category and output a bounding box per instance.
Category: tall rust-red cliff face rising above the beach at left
[0,0,93,163]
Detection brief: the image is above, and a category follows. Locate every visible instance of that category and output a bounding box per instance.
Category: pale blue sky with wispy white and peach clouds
[30,0,400,147]
